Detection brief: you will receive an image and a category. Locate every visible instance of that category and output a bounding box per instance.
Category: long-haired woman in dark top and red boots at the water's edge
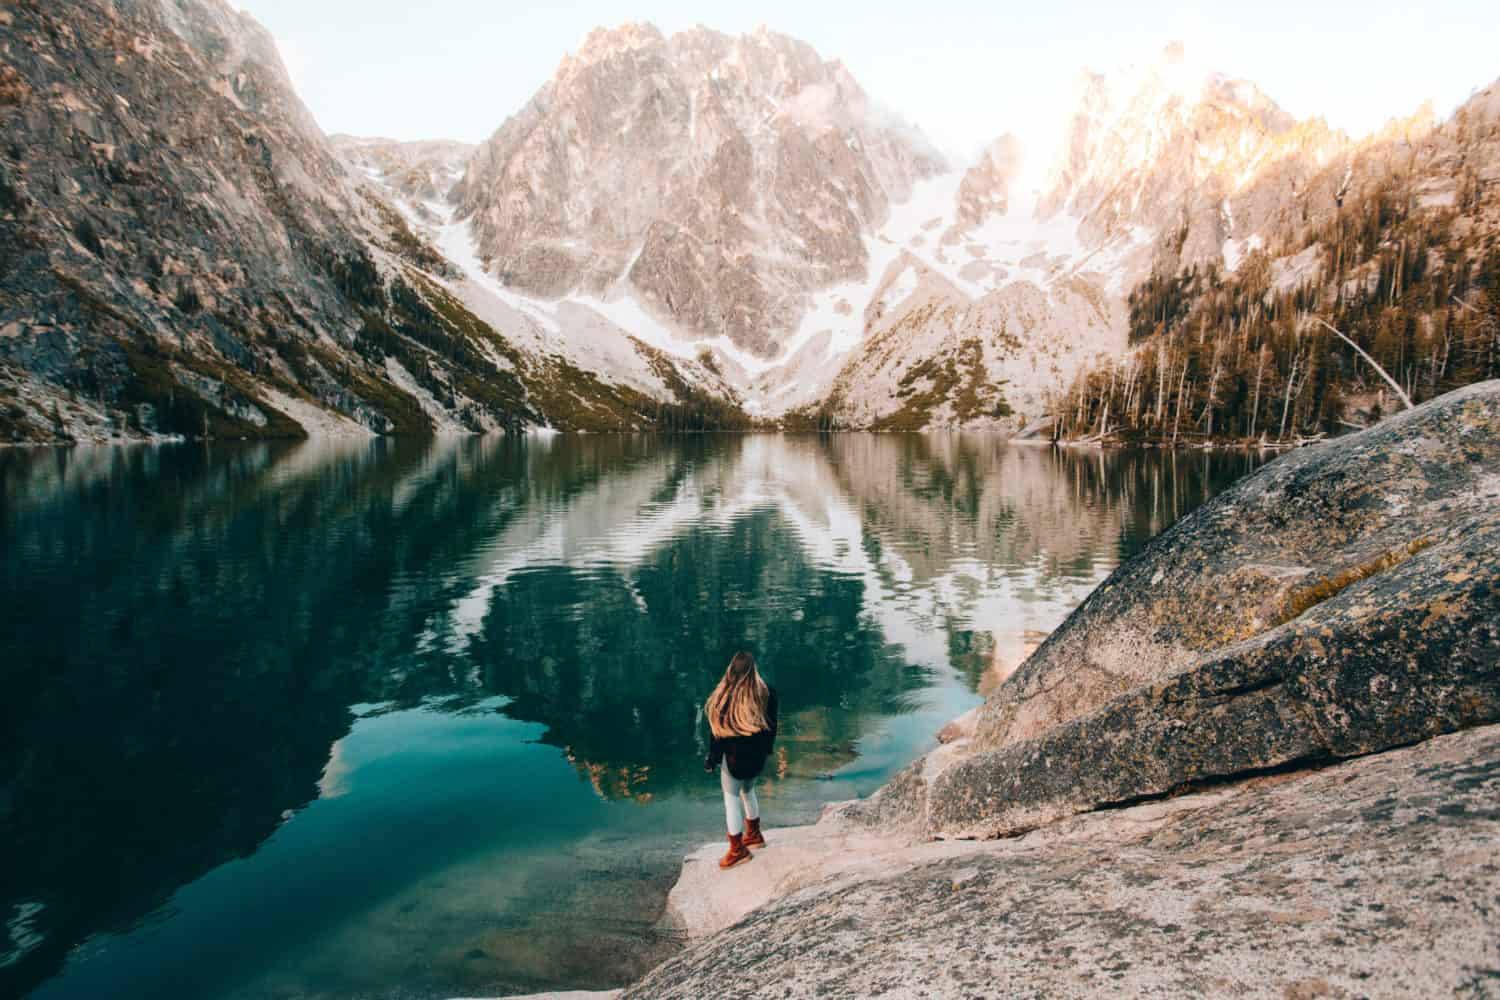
[704,652,776,868]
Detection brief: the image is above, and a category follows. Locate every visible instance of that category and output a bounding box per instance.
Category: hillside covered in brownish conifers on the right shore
[1056,74,1500,441]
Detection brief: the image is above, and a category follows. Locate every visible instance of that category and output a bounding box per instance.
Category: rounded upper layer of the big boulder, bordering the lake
[977,381,1500,748]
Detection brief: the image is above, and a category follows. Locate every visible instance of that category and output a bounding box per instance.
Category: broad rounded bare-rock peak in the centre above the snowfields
[456,24,944,358]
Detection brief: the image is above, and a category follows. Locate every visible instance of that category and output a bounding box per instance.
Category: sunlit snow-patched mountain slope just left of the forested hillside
[797,48,1343,433]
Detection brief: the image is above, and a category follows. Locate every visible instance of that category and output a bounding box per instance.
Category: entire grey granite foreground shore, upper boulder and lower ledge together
[498,382,1500,1000]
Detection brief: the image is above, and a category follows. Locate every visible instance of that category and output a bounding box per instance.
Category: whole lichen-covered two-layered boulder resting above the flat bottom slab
[845,382,1500,837]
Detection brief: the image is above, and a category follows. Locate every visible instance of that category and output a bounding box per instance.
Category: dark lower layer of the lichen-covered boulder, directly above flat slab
[926,516,1500,837]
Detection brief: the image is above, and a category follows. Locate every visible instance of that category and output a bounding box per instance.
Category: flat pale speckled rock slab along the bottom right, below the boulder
[623,726,1500,1000]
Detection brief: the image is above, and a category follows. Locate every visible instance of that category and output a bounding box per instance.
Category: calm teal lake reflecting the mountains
[0,435,1259,1000]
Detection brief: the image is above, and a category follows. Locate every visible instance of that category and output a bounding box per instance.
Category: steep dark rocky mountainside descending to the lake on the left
[0,0,743,441]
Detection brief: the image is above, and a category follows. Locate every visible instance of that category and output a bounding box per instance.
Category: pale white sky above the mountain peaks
[236,0,1500,172]
